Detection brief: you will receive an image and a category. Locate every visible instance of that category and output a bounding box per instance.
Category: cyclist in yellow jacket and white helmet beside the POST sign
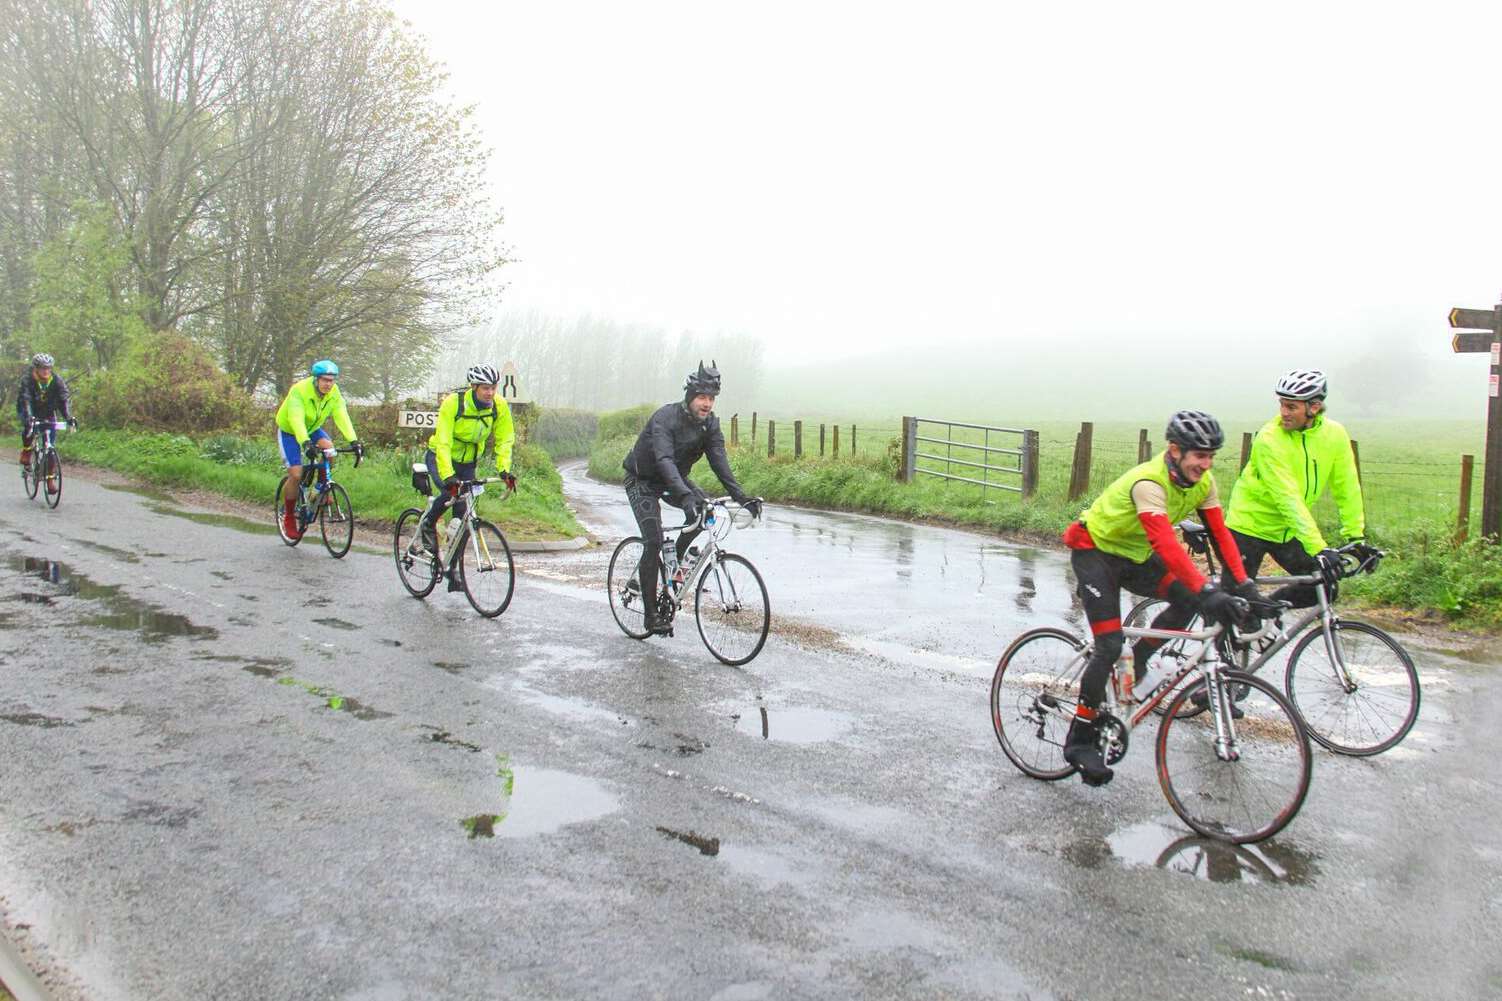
[413,365,517,591]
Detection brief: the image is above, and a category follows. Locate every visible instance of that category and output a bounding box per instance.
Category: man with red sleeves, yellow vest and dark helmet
[1063,410,1257,786]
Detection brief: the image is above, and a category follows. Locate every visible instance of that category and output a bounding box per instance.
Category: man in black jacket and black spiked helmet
[622,361,762,634]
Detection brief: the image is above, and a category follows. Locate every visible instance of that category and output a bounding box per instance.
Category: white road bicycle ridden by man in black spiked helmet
[605,497,772,667]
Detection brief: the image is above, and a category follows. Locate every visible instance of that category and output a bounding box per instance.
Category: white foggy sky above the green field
[395,0,1502,419]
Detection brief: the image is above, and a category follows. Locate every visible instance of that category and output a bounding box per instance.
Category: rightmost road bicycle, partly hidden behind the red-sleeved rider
[1125,522,1419,758]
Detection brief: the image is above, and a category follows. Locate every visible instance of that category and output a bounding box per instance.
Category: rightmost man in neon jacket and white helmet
[1226,368,1367,607]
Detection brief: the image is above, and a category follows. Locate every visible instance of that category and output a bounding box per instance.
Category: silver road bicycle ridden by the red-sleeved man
[991,598,1311,845]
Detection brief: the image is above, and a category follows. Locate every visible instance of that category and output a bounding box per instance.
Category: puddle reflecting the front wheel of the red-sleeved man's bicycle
[1063,821,1319,887]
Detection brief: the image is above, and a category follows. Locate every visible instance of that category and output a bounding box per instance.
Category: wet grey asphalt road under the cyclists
[0,462,1502,1001]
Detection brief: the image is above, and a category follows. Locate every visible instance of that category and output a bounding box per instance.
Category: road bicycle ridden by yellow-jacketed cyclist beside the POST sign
[392,463,517,619]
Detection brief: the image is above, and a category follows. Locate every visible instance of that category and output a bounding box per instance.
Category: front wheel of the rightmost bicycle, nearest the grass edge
[1283,621,1419,758]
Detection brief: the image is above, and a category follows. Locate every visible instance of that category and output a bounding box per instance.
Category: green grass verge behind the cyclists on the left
[59,431,584,541]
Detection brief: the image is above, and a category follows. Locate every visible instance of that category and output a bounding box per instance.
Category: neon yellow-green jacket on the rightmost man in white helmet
[1226,413,1367,556]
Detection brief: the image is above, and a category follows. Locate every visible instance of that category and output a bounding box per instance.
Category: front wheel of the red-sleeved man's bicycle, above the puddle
[1158,670,1313,845]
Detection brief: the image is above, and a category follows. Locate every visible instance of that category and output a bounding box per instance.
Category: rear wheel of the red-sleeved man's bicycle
[991,628,1089,782]
